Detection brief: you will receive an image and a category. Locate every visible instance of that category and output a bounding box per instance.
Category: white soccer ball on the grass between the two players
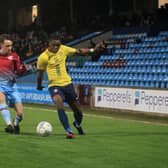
[36,121,52,137]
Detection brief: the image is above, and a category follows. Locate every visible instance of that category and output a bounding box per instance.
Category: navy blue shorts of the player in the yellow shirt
[49,84,78,102]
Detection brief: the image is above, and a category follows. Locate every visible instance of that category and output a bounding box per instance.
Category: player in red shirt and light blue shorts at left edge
[0,34,25,134]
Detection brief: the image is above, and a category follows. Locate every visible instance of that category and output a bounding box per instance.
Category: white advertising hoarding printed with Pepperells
[95,87,168,113]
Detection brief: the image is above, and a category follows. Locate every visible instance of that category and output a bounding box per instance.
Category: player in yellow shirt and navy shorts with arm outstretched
[37,38,104,139]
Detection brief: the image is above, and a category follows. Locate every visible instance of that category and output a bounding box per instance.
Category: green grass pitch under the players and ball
[0,106,168,168]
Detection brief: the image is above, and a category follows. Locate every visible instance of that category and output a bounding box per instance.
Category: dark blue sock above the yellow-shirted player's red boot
[57,109,72,132]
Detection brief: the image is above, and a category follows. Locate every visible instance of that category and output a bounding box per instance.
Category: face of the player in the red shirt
[0,40,13,54]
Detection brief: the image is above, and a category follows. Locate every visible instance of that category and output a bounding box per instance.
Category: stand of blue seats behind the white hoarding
[69,31,168,88]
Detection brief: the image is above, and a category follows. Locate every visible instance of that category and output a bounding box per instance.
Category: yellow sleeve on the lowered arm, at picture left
[37,54,48,70]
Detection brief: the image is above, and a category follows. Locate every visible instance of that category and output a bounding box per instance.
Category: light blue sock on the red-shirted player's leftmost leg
[0,104,12,125]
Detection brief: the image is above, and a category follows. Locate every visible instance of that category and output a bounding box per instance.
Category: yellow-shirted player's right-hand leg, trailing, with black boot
[66,84,84,135]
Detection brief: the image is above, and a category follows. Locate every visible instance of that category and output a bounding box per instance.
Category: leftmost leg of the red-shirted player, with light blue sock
[0,91,13,133]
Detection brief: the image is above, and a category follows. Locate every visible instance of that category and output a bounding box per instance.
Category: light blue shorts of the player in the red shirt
[0,85,22,107]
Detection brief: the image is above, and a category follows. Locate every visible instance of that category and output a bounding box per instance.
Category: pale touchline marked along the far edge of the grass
[24,106,168,126]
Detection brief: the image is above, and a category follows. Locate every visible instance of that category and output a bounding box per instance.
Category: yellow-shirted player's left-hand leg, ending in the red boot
[49,86,73,138]
